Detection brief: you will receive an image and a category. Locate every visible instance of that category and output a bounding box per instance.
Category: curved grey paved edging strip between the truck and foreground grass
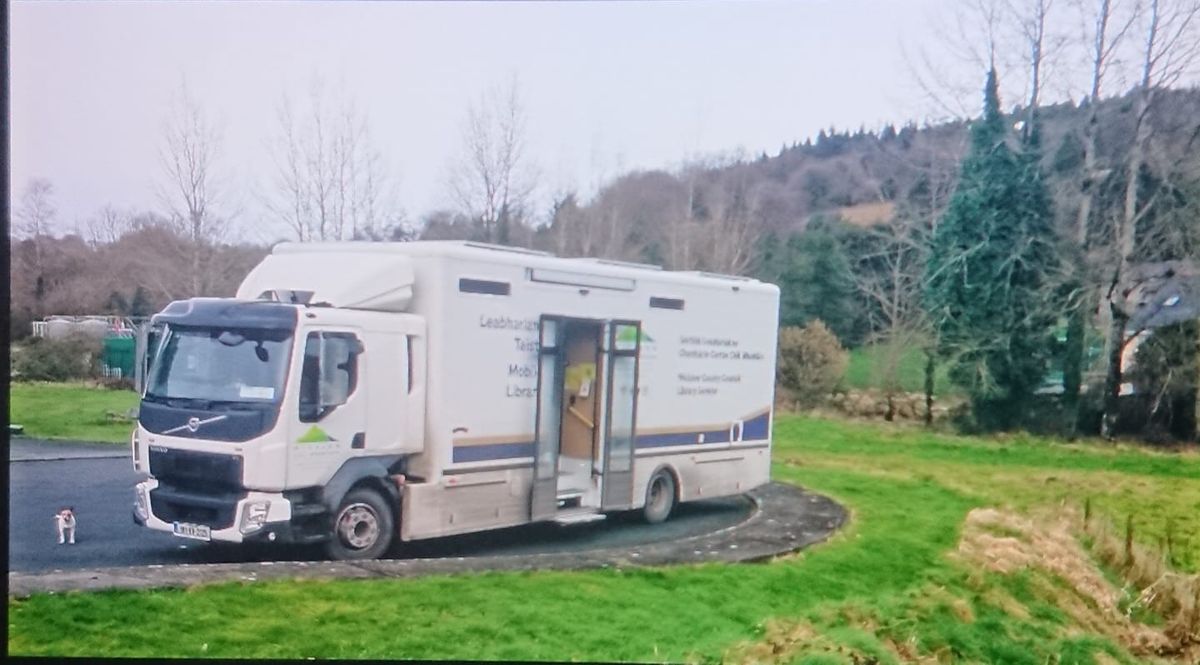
[8,483,847,597]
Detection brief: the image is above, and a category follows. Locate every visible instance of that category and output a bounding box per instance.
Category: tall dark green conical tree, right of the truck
[925,70,1057,429]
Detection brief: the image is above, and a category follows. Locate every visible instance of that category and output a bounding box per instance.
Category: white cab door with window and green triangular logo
[288,328,368,487]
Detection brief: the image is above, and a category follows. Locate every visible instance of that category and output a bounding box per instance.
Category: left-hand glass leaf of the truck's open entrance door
[529,316,564,521]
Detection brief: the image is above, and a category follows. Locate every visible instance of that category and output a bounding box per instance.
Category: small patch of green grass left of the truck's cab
[8,383,138,443]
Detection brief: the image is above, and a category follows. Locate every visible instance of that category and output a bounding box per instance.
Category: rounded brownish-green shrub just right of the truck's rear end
[779,320,850,407]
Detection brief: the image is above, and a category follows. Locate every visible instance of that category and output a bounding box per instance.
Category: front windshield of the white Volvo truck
[146,325,292,405]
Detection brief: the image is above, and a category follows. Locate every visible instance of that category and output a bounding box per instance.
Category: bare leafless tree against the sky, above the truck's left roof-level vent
[449,78,534,242]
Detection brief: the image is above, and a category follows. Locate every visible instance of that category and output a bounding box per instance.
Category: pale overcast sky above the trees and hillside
[10,0,1108,239]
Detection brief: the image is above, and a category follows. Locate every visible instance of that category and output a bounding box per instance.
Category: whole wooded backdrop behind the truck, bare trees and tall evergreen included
[10,0,1200,437]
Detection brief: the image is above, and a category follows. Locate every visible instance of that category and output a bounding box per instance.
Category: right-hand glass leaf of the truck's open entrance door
[600,320,642,510]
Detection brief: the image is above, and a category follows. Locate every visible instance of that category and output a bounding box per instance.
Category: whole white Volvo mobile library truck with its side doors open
[133,242,779,558]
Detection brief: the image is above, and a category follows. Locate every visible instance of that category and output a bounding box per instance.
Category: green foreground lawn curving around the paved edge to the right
[8,417,1200,664]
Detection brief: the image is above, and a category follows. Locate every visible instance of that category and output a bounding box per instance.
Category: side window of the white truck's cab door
[300,333,362,423]
